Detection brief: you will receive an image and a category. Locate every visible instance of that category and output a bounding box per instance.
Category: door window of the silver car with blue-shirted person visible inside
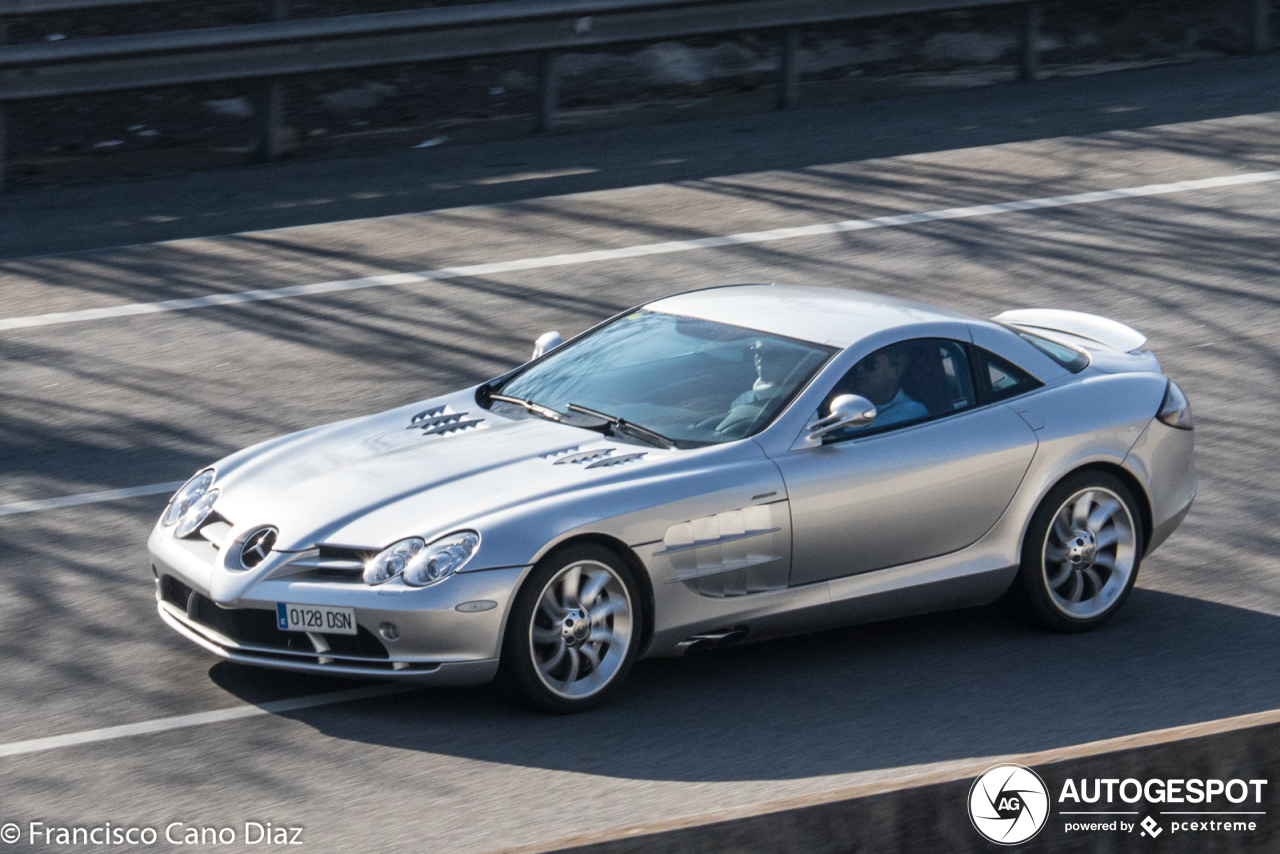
[822,338,975,442]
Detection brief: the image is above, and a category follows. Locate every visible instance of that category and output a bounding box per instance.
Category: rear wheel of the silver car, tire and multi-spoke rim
[1010,471,1146,632]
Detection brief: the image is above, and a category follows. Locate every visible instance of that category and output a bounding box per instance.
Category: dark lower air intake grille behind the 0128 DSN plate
[160,575,390,659]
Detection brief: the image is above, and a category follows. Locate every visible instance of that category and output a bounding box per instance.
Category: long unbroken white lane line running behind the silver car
[0,170,1280,332]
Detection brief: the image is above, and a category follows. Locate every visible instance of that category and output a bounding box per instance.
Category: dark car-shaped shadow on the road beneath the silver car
[210,590,1280,781]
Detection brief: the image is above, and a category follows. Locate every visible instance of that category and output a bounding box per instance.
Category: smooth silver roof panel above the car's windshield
[644,284,975,347]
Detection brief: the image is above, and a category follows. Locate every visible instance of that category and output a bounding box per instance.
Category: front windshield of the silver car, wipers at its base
[495,310,835,446]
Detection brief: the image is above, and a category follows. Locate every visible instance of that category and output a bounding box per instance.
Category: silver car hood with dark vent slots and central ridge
[215,391,672,551]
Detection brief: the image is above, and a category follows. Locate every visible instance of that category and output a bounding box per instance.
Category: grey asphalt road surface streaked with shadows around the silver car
[0,60,1280,853]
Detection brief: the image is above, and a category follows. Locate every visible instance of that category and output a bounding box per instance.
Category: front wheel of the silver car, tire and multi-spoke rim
[500,544,644,714]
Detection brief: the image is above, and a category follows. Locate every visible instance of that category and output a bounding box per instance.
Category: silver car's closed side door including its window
[774,338,1037,585]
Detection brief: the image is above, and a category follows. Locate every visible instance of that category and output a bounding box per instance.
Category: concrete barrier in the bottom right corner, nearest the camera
[503,709,1280,854]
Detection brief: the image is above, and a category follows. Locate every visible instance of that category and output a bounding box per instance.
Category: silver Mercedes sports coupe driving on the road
[148,286,1196,712]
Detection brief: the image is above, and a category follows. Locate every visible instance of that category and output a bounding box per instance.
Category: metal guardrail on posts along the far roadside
[0,0,1270,187]
